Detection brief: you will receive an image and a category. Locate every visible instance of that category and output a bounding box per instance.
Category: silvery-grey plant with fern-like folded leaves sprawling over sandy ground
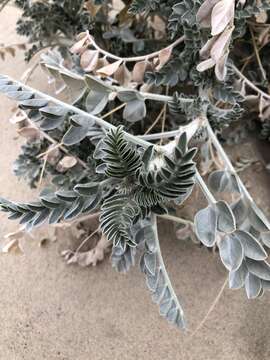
[0,0,270,328]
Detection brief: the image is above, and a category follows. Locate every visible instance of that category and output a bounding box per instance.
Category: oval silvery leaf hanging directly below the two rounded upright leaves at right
[219,234,244,271]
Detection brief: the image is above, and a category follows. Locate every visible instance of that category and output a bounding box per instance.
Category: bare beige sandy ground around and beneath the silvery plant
[0,8,270,360]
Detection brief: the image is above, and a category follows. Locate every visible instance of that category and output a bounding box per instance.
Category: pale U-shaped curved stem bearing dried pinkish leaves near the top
[87,32,185,62]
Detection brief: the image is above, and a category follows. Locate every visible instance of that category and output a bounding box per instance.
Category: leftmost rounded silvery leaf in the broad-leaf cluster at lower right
[194,205,218,247]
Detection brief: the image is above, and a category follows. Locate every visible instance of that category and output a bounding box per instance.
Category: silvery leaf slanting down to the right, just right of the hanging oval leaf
[233,230,267,260]
